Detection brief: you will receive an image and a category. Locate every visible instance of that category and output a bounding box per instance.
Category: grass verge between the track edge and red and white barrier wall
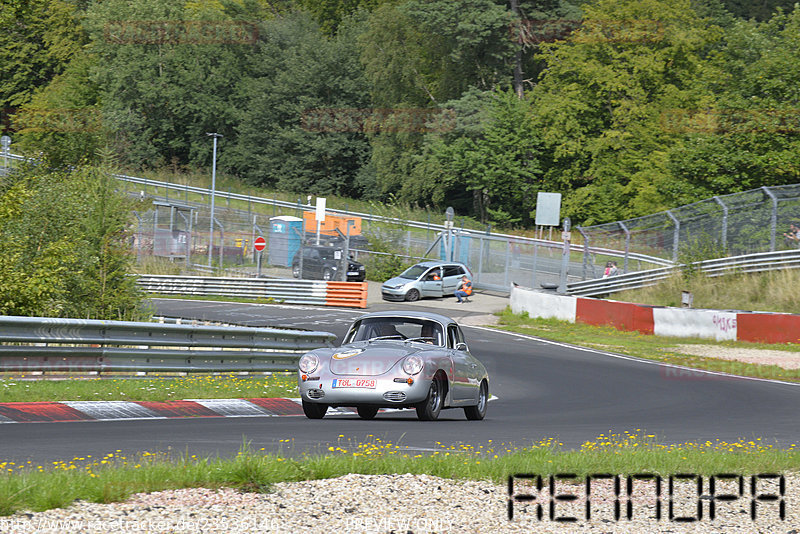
[499,308,800,382]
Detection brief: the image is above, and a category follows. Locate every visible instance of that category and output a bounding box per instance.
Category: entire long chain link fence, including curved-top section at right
[119,170,800,292]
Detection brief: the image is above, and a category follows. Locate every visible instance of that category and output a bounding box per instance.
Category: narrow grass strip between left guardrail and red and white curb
[0,373,299,402]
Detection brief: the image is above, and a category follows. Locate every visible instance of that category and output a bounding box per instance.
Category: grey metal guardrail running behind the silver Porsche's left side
[0,316,336,372]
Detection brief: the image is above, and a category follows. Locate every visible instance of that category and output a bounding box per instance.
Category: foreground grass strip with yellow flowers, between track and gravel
[0,433,800,515]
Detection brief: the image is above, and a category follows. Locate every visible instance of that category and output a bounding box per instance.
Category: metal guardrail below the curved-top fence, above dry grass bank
[567,250,800,297]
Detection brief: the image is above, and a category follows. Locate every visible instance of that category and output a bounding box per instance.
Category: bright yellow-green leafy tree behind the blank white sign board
[534,0,722,223]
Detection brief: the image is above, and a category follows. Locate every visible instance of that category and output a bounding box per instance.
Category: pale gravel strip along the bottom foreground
[0,474,800,534]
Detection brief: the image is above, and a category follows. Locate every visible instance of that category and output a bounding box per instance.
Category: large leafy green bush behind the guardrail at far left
[0,161,146,320]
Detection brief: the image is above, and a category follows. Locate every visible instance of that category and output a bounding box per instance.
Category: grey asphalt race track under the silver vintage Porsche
[0,300,800,462]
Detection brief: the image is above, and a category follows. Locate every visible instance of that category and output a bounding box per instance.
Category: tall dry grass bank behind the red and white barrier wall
[613,269,800,313]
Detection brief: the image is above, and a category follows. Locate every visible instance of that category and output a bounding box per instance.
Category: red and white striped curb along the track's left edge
[0,398,316,424]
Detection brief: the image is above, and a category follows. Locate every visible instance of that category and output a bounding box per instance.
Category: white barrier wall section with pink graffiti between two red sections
[653,308,737,341]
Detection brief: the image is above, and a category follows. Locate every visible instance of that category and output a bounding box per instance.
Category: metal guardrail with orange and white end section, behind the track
[136,275,367,308]
